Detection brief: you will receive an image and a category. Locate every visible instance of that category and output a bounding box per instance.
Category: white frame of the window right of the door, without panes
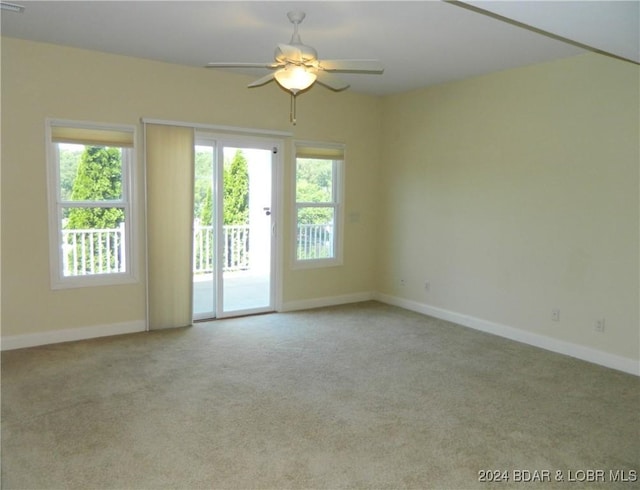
[291,140,345,269]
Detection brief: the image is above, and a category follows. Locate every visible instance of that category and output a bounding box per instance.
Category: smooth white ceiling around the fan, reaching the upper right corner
[2,0,640,95]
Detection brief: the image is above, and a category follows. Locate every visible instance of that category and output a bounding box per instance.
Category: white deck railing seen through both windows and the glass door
[62,223,333,276]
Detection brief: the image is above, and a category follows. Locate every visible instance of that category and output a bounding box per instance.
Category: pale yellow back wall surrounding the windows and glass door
[2,38,381,337]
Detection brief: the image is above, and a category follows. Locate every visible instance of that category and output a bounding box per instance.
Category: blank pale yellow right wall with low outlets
[377,54,640,359]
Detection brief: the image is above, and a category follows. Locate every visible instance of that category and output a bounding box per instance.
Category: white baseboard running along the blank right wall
[373,293,640,376]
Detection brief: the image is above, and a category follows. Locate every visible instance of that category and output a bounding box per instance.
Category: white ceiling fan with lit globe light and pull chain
[206,11,384,124]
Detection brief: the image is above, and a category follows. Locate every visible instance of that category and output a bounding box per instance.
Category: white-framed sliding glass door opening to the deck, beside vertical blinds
[193,134,281,320]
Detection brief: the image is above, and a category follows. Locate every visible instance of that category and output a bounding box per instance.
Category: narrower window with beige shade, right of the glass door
[294,142,344,267]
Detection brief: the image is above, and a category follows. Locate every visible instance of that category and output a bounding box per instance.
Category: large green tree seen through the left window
[67,146,124,230]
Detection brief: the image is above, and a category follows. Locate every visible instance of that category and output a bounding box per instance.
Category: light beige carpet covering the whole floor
[2,302,640,489]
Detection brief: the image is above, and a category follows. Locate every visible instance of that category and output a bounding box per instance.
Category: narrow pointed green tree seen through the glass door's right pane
[223,150,249,225]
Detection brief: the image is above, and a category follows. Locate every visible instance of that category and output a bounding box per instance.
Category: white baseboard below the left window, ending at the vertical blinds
[0,320,146,351]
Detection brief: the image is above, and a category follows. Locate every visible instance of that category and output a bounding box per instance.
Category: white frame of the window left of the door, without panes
[45,119,138,289]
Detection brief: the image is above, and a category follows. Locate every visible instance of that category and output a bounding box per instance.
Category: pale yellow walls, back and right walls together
[2,39,640,368]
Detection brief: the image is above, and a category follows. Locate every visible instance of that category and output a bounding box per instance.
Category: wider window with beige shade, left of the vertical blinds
[47,120,134,289]
